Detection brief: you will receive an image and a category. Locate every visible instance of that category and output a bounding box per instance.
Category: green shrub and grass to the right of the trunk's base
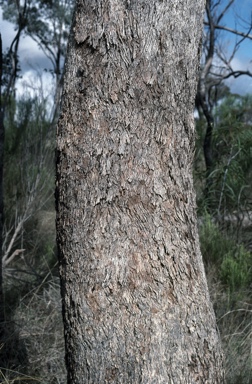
[203,217,252,384]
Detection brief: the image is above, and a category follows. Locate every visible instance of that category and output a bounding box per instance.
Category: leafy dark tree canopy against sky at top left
[0,0,74,76]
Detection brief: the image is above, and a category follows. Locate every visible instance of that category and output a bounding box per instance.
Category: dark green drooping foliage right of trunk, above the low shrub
[195,95,252,215]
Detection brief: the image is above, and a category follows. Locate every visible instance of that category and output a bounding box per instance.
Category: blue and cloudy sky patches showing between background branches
[0,0,252,94]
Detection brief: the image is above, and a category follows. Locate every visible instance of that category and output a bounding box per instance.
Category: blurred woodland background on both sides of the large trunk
[0,0,252,384]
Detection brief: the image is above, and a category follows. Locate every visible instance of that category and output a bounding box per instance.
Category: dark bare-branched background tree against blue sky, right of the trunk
[196,0,252,202]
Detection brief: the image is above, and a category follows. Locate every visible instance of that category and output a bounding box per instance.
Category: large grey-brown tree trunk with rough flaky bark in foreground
[56,0,223,384]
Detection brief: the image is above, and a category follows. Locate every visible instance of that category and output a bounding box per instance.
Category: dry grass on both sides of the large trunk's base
[0,258,252,384]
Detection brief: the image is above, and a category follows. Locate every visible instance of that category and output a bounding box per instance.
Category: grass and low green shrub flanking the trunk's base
[0,212,252,384]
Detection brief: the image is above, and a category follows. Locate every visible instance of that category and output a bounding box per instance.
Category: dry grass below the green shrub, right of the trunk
[207,265,252,384]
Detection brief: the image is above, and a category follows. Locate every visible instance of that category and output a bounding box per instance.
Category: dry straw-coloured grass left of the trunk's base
[0,278,66,384]
